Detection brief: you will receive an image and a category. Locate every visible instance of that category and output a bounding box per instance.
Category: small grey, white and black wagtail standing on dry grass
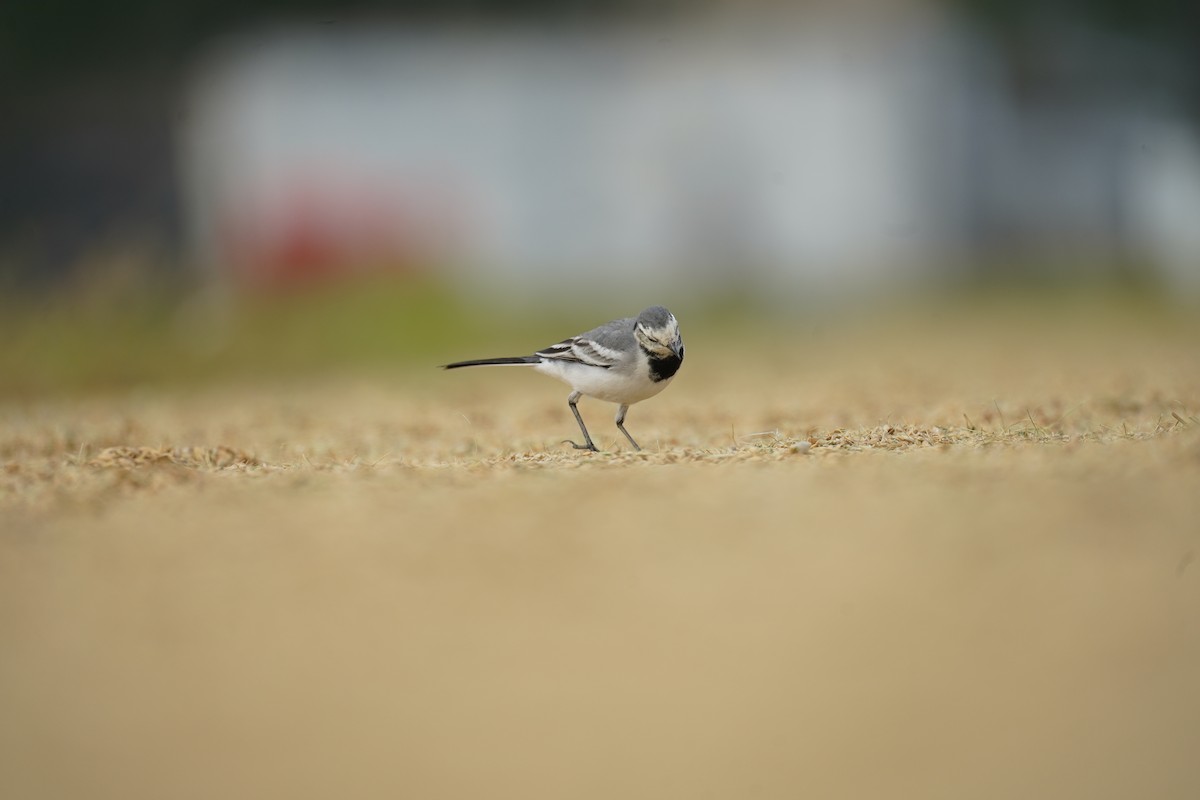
[444,306,683,451]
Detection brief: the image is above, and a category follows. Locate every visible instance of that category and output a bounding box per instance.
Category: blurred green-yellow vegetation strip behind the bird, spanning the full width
[0,257,1180,401]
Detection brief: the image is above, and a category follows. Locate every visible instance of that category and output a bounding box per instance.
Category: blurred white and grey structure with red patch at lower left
[180,14,1200,295]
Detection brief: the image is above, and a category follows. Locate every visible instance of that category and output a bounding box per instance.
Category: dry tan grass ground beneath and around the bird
[0,297,1200,799]
